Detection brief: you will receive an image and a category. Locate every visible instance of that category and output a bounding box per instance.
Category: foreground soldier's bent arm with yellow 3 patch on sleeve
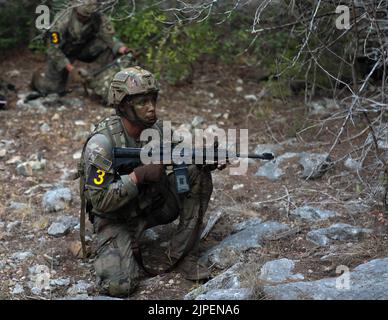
[84,134,138,213]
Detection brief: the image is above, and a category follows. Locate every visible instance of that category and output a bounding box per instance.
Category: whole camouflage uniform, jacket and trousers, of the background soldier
[32,9,124,94]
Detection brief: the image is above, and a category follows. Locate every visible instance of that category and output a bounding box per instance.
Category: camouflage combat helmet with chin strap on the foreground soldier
[108,66,159,127]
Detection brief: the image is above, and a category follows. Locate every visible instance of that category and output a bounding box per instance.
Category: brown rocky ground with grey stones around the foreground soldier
[0,52,388,299]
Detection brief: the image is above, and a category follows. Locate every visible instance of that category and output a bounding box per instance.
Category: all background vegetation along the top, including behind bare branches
[0,0,378,92]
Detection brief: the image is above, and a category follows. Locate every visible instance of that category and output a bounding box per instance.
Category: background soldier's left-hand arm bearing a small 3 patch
[47,12,71,71]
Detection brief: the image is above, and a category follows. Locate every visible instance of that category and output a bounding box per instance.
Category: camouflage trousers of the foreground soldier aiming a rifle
[94,165,213,296]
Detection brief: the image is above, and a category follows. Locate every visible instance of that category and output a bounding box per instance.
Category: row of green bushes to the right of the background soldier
[113,8,301,86]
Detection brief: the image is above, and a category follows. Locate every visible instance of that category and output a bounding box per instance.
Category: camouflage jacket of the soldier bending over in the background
[48,10,124,70]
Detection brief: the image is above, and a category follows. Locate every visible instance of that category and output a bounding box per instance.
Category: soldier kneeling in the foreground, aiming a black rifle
[80,67,214,296]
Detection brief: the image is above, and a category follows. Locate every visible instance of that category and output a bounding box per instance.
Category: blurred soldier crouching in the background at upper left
[31,0,131,95]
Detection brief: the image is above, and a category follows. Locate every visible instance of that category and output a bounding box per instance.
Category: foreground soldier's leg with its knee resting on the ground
[94,218,139,297]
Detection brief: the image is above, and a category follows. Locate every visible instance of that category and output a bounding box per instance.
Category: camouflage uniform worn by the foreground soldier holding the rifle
[82,116,213,296]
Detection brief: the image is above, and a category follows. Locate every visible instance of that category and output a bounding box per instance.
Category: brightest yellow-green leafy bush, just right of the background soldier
[114,10,217,83]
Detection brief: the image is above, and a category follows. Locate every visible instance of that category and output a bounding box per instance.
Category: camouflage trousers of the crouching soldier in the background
[31,39,115,94]
